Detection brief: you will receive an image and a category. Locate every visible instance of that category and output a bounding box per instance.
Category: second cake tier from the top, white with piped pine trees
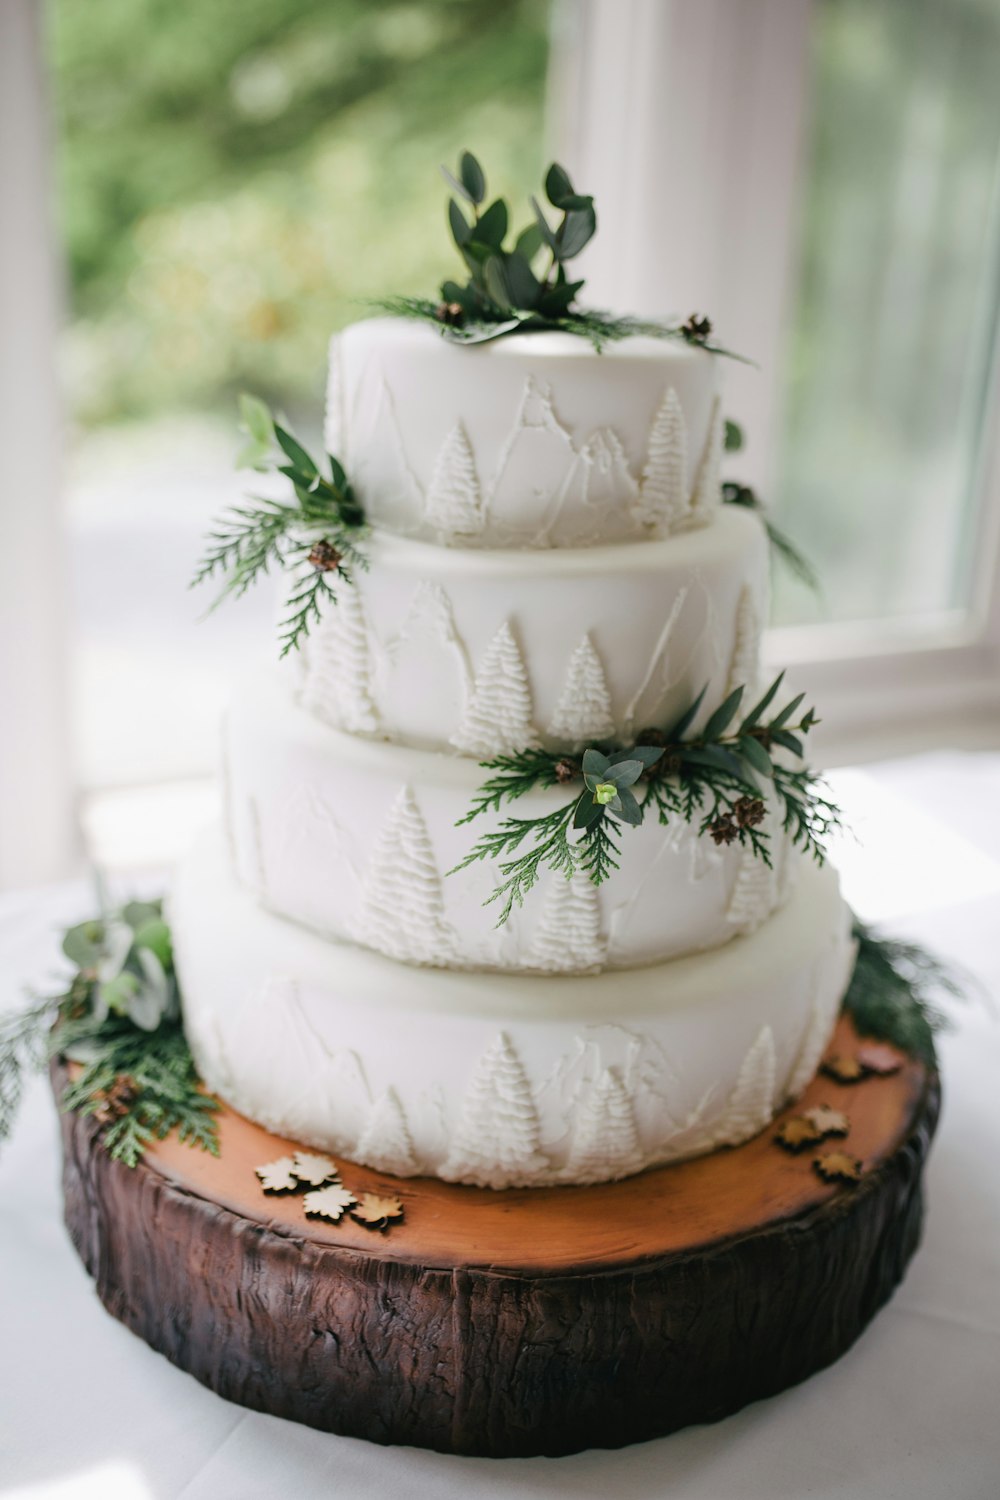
[284,506,768,756]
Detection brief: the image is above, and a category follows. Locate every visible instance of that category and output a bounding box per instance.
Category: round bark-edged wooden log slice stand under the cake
[57,1020,939,1457]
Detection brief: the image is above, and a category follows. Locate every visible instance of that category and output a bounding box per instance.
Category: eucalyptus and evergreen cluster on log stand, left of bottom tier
[0,902,219,1167]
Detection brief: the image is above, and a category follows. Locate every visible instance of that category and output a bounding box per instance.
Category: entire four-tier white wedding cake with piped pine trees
[172,320,852,1188]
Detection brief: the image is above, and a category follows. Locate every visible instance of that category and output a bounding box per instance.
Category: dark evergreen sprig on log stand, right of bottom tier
[844,918,967,1068]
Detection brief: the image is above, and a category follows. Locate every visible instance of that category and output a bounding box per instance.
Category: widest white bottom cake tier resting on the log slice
[171,834,853,1188]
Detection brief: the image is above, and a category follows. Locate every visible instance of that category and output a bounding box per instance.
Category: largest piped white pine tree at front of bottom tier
[441,1032,549,1188]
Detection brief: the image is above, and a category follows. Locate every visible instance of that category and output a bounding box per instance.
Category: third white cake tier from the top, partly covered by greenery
[229,671,799,969]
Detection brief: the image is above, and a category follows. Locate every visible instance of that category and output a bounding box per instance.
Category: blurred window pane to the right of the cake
[775,0,1000,623]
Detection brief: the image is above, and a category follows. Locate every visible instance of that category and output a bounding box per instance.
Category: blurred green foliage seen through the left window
[49,0,549,425]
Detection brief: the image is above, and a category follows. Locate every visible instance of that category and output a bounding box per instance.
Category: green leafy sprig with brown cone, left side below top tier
[192,396,367,656]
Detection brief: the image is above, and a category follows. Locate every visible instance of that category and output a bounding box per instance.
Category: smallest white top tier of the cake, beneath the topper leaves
[325,318,723,548]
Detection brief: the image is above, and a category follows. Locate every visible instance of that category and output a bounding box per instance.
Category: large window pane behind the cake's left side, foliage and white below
[49,0,549,788]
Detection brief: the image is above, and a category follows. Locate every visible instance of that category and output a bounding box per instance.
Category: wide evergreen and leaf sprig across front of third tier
[451,674,840,926]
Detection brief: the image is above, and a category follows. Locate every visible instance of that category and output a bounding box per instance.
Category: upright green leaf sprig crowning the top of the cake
[376,152,750,363]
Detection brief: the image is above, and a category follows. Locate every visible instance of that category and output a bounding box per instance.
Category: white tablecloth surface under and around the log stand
[0,753,1000,1500]
